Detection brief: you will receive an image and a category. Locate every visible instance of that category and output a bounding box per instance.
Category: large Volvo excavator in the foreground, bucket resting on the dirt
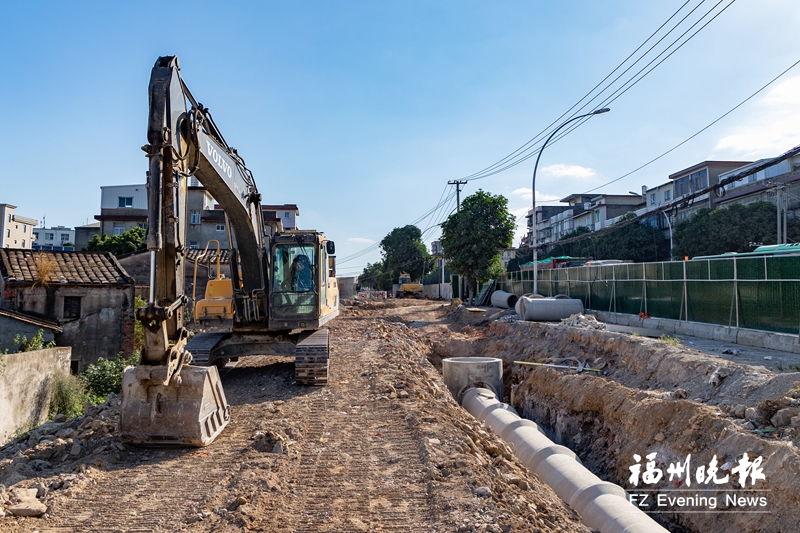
[120,56,339,447]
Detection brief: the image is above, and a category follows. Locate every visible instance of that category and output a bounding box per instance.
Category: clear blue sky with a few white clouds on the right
[0,0,800,274]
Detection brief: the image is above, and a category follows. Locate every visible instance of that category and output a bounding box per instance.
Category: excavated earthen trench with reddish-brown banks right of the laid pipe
[431,311,800,533]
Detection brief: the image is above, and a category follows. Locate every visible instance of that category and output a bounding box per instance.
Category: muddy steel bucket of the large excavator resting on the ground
[119,366,230,446]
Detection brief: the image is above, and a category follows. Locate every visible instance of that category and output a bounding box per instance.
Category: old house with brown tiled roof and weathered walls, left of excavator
[0,249,134,371]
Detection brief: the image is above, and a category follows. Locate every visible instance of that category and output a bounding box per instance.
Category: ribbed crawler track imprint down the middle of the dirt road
[289,336,434,533]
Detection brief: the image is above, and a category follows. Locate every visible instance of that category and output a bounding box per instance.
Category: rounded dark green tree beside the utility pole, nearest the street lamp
[441,190,515,297]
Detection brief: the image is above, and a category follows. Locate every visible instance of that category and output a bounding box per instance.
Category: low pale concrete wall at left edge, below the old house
[0,347,71,445]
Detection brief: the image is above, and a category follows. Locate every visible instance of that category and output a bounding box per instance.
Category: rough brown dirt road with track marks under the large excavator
[0,302,589,533]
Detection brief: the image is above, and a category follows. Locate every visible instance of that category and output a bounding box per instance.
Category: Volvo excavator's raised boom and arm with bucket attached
[120,56,269,446]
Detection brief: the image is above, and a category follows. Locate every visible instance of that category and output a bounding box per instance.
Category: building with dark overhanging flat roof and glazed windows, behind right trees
[669,161,750,222]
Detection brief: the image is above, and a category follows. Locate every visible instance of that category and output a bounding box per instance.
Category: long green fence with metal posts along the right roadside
[500,256,800,334]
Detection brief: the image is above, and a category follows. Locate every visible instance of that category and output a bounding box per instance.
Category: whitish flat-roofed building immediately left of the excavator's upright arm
[94,183,147,235]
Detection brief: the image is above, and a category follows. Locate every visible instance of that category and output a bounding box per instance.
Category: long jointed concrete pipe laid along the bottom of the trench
[462,388,667,533]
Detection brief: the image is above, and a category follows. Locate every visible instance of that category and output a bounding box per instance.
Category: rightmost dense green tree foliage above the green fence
[673,202,800,257]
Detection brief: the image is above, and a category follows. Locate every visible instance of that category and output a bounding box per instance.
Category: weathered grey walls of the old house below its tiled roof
[4,283,134,370]
